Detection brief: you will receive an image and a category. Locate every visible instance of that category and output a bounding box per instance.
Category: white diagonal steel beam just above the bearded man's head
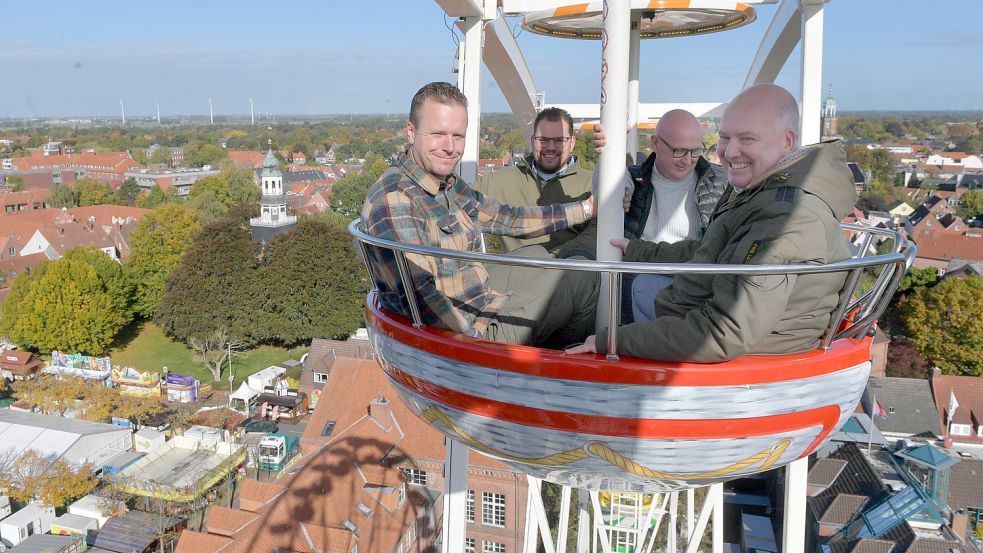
[482,17,539,139]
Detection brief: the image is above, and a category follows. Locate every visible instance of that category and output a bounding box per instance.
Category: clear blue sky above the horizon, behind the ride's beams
[0,0,983,117]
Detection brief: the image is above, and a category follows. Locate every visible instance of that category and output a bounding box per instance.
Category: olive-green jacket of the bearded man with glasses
[472,154,593,253]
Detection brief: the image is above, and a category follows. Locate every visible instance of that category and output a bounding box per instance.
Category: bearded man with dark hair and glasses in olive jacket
[472,108,593,255]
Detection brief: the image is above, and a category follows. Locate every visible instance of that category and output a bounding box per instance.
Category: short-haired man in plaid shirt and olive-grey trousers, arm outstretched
[362,83,598,346]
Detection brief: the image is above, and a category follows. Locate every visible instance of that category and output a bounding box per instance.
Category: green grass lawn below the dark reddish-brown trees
[109,321,307,390]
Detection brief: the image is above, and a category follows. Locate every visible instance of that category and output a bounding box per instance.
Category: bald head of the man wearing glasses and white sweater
[652,109,703,180]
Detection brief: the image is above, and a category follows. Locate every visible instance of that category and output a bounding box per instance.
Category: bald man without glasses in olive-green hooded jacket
[567,85,856,363]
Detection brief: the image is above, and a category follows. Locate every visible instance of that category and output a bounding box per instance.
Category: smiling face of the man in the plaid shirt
[406,100,468,180]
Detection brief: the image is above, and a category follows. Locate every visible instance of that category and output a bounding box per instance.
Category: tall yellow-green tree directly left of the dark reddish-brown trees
[125,204,201,317]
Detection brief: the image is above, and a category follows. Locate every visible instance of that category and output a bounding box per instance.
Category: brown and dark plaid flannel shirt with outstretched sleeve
[362,154,585,336]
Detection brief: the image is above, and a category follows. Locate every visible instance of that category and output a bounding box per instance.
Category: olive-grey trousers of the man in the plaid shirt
[485,246,600,348]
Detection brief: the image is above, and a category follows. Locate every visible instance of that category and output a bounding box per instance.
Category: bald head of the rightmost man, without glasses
[717,84,799,190]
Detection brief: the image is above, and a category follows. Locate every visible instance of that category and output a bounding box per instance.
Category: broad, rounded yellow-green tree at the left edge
[4,256,130,354]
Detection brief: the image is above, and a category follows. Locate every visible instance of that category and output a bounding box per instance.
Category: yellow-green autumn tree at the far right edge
[899,276,983,376]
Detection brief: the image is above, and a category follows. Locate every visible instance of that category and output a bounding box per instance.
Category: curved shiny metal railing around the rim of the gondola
[348,220,916,356]
